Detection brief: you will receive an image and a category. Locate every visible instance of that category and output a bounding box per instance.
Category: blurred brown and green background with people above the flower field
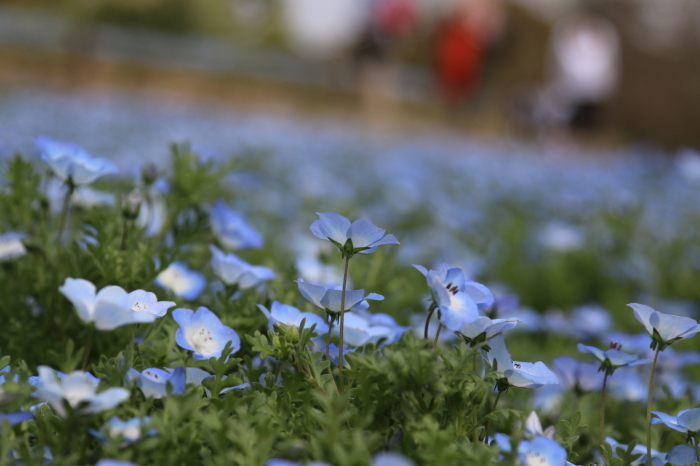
[0,0,700,148]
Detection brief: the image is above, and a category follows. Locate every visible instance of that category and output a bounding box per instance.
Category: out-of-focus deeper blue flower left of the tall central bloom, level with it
[209,201,263,249]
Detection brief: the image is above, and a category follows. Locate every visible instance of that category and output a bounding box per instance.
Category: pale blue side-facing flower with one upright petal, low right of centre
[482,335,559,391]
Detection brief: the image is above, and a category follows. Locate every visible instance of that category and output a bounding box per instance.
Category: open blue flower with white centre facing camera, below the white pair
[173,307,241,359]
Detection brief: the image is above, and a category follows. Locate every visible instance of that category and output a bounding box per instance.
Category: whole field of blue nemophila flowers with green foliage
[0,91,700,466]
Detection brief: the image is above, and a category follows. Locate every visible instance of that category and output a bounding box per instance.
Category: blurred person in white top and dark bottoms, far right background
[532,14,620,129]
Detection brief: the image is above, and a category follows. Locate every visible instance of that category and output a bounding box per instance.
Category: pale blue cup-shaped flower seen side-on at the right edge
[628,303,700,351]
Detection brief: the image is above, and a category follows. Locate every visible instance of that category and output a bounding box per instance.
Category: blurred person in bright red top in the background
[434,0,504,106]
